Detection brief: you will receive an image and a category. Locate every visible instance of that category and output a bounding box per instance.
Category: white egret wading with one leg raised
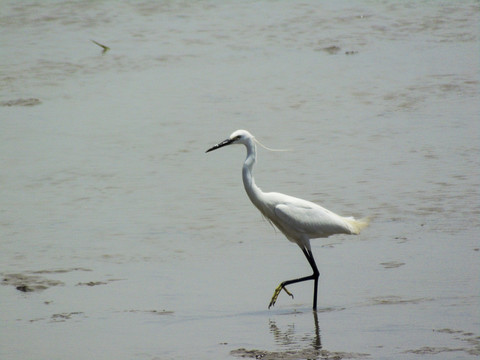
[206,130,368,310]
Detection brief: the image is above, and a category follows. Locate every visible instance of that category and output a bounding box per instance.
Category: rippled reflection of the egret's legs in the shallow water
[269,311,322,355]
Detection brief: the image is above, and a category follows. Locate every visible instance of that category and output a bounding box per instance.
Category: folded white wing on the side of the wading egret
[275,201,351,238]
